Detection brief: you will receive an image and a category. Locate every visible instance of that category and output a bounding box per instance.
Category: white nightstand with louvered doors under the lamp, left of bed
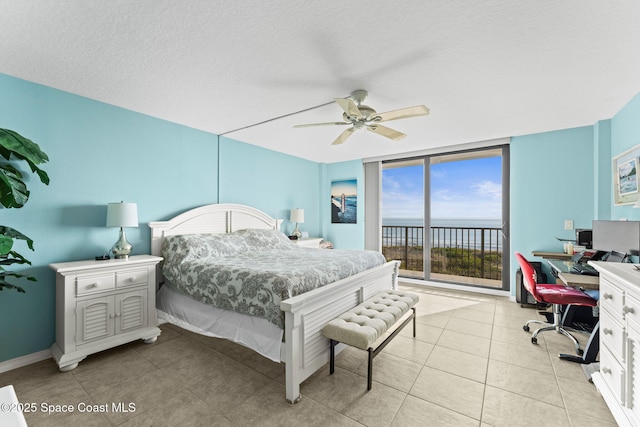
[50,255,162,371]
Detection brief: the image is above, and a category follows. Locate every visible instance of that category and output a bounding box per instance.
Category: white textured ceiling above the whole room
[0,0,640,162]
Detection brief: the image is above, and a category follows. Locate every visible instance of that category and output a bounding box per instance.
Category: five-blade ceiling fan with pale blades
[294,90,429,145]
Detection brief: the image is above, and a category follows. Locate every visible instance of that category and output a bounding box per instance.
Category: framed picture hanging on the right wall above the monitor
[612,144,640,206]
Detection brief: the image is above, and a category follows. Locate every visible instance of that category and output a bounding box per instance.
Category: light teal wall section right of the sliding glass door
[510,127,594,280]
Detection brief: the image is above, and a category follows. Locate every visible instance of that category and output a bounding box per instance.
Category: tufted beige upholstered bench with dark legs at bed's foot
[322,290,419,390]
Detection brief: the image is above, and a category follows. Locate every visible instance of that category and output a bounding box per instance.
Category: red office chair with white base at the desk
[515,252,597,354]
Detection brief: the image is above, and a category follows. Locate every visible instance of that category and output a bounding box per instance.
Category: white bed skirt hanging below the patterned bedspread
[156,286,284,362]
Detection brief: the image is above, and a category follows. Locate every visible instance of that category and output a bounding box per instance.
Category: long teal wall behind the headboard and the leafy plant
[0,74,323,362]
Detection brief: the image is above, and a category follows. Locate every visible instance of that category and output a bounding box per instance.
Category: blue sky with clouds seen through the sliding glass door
[382,157,502,219]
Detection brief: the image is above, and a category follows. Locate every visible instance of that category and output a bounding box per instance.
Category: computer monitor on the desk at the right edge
[591,220,640,254]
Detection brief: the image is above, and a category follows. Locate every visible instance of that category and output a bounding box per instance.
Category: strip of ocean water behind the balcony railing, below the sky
[382,218,502,250]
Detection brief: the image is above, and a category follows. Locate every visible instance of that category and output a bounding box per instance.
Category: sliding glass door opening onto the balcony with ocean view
[381,146,509,289]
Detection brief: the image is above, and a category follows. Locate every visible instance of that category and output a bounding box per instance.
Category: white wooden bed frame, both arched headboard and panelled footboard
[149,204,400,403]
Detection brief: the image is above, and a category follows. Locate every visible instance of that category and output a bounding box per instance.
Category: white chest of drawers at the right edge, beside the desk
[589,262,640,426]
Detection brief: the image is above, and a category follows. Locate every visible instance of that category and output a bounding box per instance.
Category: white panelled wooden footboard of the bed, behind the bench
[280,261,400,403]
